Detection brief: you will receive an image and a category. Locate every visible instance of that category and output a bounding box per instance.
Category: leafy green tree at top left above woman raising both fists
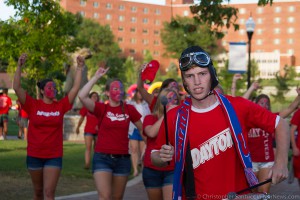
[0,0,82,98]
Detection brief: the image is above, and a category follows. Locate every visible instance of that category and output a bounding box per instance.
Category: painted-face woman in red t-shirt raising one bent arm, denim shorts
[78,67,142,199]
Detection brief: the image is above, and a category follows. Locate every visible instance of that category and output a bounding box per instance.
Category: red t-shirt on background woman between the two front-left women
[79,107,99,135]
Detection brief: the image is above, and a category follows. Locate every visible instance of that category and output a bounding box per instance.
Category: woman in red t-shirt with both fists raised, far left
[13,54,84,199]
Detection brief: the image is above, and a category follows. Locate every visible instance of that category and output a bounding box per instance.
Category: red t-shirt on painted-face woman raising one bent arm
[94,102,141,154]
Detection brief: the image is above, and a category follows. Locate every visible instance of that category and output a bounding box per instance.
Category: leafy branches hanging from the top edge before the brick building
[191,0,273,38]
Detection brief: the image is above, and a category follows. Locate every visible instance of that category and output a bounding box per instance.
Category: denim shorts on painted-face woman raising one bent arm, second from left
[92,152,131,176]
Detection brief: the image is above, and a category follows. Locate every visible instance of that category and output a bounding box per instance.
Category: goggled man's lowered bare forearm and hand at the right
[269,117,290,184]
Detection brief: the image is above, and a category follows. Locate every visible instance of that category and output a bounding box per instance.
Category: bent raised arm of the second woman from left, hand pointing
[78,66,109,112]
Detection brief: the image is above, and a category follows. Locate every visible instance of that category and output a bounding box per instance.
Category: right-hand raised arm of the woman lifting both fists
[68,56,85,104]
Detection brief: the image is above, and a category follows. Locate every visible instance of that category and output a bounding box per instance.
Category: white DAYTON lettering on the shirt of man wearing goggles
[191,128,233,169]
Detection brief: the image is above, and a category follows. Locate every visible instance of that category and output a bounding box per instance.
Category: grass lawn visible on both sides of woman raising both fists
[0,140,95,200]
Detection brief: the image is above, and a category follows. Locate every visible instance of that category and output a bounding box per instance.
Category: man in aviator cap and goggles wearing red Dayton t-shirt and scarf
[151,46,289,199]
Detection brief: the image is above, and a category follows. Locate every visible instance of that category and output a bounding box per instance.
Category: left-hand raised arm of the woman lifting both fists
[13,53,27,104]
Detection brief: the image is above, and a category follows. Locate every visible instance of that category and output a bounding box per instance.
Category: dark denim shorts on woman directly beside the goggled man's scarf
[143,167,174,188]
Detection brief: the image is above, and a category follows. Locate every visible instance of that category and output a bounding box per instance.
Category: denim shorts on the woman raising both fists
[26,156,62,170]
